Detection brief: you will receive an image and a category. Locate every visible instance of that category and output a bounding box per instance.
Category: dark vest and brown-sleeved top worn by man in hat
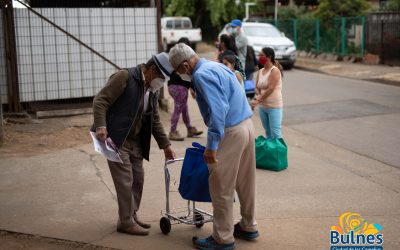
[92,65,170,160]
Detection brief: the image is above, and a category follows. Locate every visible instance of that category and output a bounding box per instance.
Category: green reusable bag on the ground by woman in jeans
[256,135,288,171]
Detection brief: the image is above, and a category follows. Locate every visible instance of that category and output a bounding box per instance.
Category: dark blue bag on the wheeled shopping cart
[178,142,211,202]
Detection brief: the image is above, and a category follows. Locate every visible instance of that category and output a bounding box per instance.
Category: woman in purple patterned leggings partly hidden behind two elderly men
[168,38,203,141]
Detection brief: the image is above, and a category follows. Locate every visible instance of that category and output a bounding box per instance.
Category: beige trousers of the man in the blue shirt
[208,119,257,244]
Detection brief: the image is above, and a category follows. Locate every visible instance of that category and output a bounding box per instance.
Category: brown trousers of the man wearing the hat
[108,141,144,228]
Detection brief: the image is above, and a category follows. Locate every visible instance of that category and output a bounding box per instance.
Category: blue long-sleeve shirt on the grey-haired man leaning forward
[192,59,253,150]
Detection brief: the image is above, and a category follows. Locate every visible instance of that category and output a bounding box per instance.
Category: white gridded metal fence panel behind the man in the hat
[0,4,158,107]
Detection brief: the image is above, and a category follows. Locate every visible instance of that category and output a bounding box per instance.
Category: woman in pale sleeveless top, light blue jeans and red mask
[251,47,283,139]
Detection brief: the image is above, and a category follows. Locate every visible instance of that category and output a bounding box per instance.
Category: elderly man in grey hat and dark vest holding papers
[92,52,175,235]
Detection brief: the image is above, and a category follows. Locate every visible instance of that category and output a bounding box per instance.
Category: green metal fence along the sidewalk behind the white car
[267,17,365,56]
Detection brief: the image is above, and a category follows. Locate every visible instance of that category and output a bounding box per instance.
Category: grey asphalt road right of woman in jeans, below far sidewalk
[283,70,400,168]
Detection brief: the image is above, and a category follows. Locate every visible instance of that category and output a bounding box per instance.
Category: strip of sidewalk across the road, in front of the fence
[295,57,400,86]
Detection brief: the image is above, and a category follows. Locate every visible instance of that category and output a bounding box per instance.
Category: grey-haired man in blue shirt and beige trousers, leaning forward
[169,43,259,249]
